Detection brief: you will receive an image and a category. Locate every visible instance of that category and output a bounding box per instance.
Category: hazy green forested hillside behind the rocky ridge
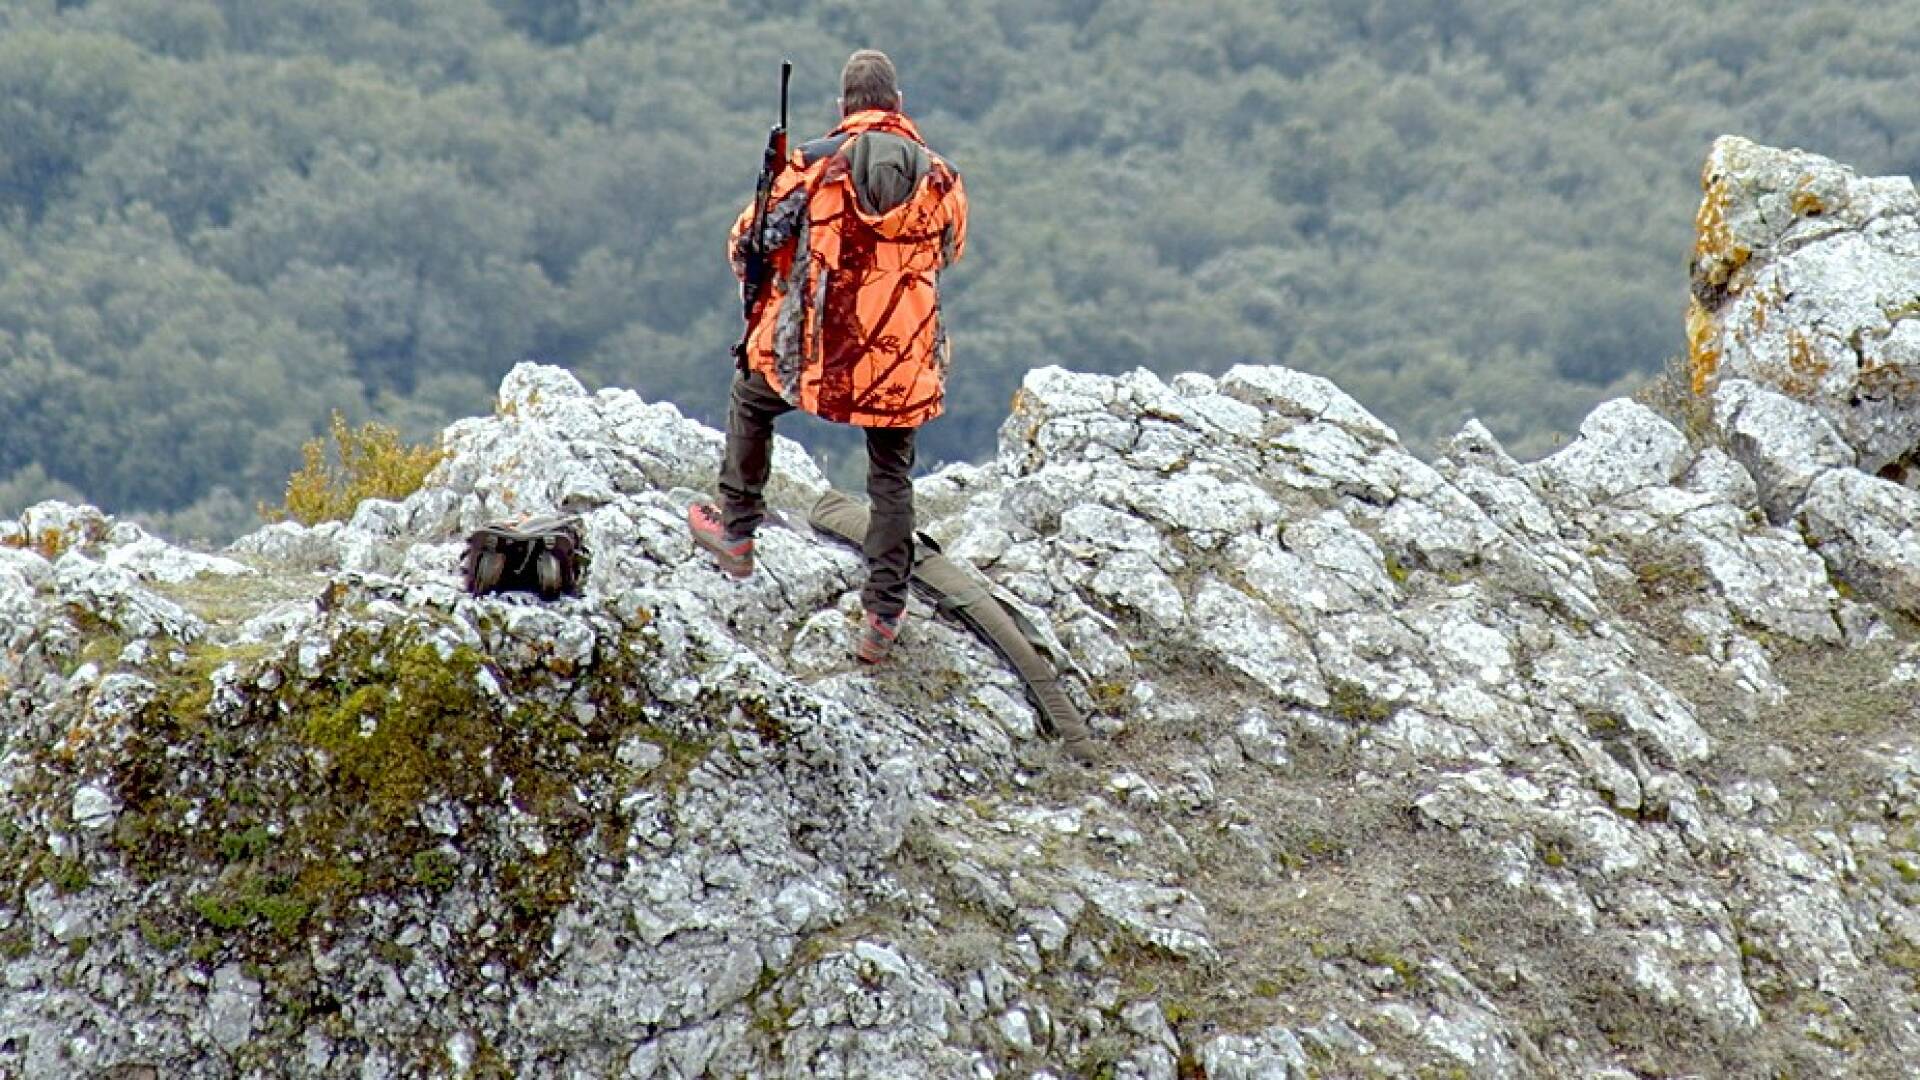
[0,0,1920,540]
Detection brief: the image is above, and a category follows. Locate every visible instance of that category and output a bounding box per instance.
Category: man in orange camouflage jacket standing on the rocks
[687,50,968,663]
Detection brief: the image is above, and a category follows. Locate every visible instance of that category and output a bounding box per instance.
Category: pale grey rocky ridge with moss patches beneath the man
[0,140,1920,1080]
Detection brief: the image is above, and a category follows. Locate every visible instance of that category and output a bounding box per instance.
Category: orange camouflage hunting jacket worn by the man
[728,110,966,427]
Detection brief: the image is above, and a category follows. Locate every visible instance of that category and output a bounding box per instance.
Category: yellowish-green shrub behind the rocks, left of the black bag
[261,413,445,525]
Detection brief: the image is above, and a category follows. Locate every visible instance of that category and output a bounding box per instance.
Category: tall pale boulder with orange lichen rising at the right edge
[1688,136,1920,611]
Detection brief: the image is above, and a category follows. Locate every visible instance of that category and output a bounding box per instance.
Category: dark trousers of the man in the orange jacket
[720,371,918,619]
